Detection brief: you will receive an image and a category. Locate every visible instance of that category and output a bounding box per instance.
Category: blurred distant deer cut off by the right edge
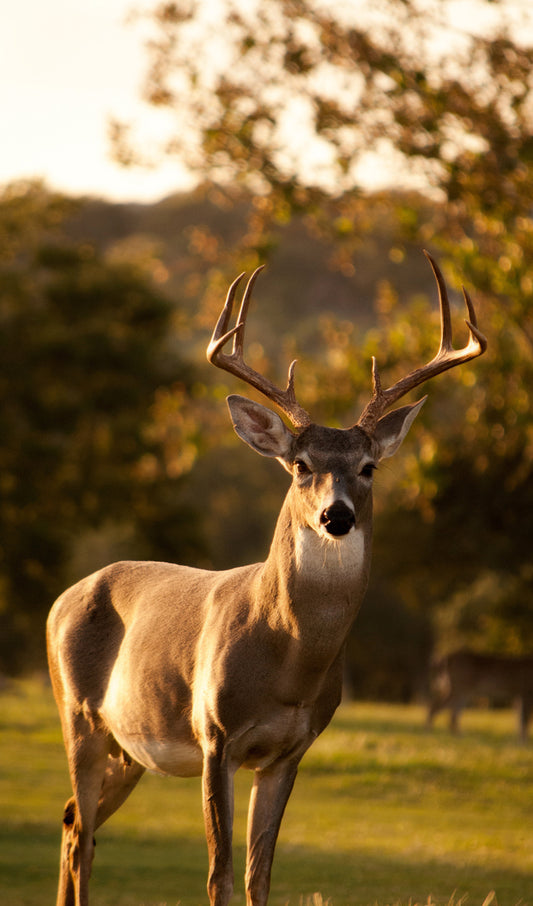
[428,651,533,742]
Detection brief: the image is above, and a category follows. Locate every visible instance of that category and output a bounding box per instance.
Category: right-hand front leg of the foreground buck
[246,760,298,906]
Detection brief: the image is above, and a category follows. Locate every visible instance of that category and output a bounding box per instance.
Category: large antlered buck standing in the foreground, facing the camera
[47,256,486,906]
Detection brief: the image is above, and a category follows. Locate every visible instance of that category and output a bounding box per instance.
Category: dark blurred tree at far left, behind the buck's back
[0,184,204,670]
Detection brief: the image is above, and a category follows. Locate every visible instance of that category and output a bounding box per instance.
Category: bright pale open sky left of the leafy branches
[0,0,191,201]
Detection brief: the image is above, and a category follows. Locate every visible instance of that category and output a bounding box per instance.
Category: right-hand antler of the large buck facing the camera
[357,251,487,431]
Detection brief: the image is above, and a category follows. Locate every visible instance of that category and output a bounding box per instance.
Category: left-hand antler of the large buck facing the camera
[206,265,311,428]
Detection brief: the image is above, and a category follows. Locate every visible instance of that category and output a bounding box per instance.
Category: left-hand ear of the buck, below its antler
[227,394,294,460]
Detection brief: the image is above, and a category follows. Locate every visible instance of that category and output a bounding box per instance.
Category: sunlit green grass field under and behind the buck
[0,681,533,906]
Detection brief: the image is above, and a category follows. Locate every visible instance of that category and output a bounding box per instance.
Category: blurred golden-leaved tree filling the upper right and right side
[109,0,533,680]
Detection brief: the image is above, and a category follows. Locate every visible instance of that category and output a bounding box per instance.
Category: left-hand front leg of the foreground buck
[202,744,235,906]
